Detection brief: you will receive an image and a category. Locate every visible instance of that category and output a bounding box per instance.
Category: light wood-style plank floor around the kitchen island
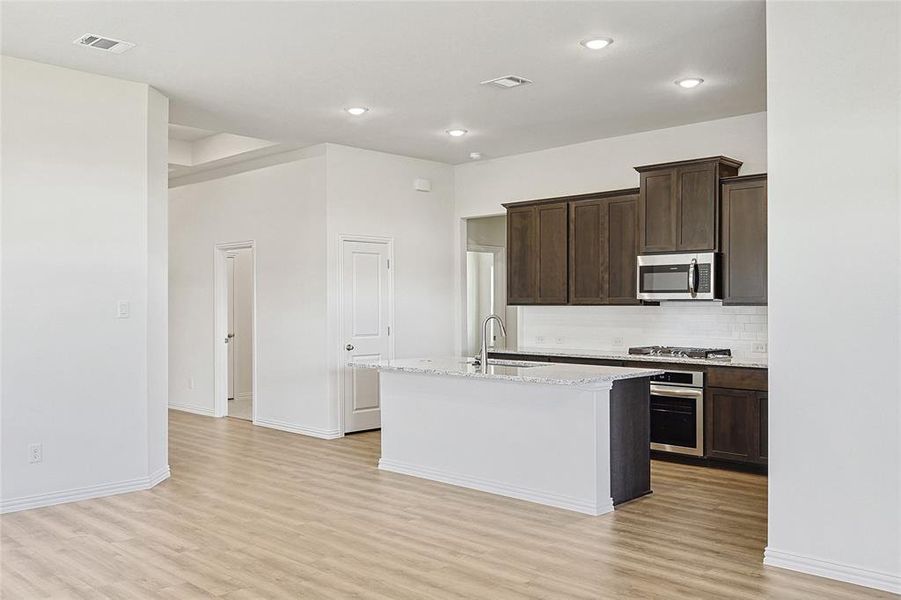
[0,412,893,600]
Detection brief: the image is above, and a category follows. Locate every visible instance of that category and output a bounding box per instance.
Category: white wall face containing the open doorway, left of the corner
[169,146,332,436]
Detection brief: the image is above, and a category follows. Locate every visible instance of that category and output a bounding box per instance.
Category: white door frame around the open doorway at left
[213,240,259,424]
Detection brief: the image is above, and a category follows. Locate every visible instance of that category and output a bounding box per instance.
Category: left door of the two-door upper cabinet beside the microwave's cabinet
[569,199,607,304]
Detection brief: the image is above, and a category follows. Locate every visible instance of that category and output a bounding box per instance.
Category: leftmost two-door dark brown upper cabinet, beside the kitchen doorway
[505,201,569,304]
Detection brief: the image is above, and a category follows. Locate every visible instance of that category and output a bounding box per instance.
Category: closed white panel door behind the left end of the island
[341,240,391,433]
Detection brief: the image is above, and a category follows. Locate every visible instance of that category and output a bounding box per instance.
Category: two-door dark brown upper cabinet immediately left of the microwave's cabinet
[569,189,638,304]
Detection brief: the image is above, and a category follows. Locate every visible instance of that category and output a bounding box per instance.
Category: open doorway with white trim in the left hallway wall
[214,242,257,421]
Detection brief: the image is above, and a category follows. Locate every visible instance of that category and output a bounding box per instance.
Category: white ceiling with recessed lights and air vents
[0,0,766,163]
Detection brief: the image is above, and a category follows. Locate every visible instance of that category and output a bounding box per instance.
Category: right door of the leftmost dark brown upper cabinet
[537,202,569,304]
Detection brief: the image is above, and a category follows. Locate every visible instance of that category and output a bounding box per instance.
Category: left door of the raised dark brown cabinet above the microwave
[638,169,678,252]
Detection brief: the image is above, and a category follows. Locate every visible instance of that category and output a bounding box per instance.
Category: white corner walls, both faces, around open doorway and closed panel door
[170,144,453,437]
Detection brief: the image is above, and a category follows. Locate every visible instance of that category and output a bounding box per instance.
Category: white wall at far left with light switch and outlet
[0,57,168,511]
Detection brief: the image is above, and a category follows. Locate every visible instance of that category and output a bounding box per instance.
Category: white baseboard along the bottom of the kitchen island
[379,458,613,516]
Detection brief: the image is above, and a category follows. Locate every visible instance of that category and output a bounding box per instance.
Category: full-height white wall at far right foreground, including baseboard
[766,2,901,592]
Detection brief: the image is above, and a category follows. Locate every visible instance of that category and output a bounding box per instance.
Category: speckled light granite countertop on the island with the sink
[348,357,663,386]
